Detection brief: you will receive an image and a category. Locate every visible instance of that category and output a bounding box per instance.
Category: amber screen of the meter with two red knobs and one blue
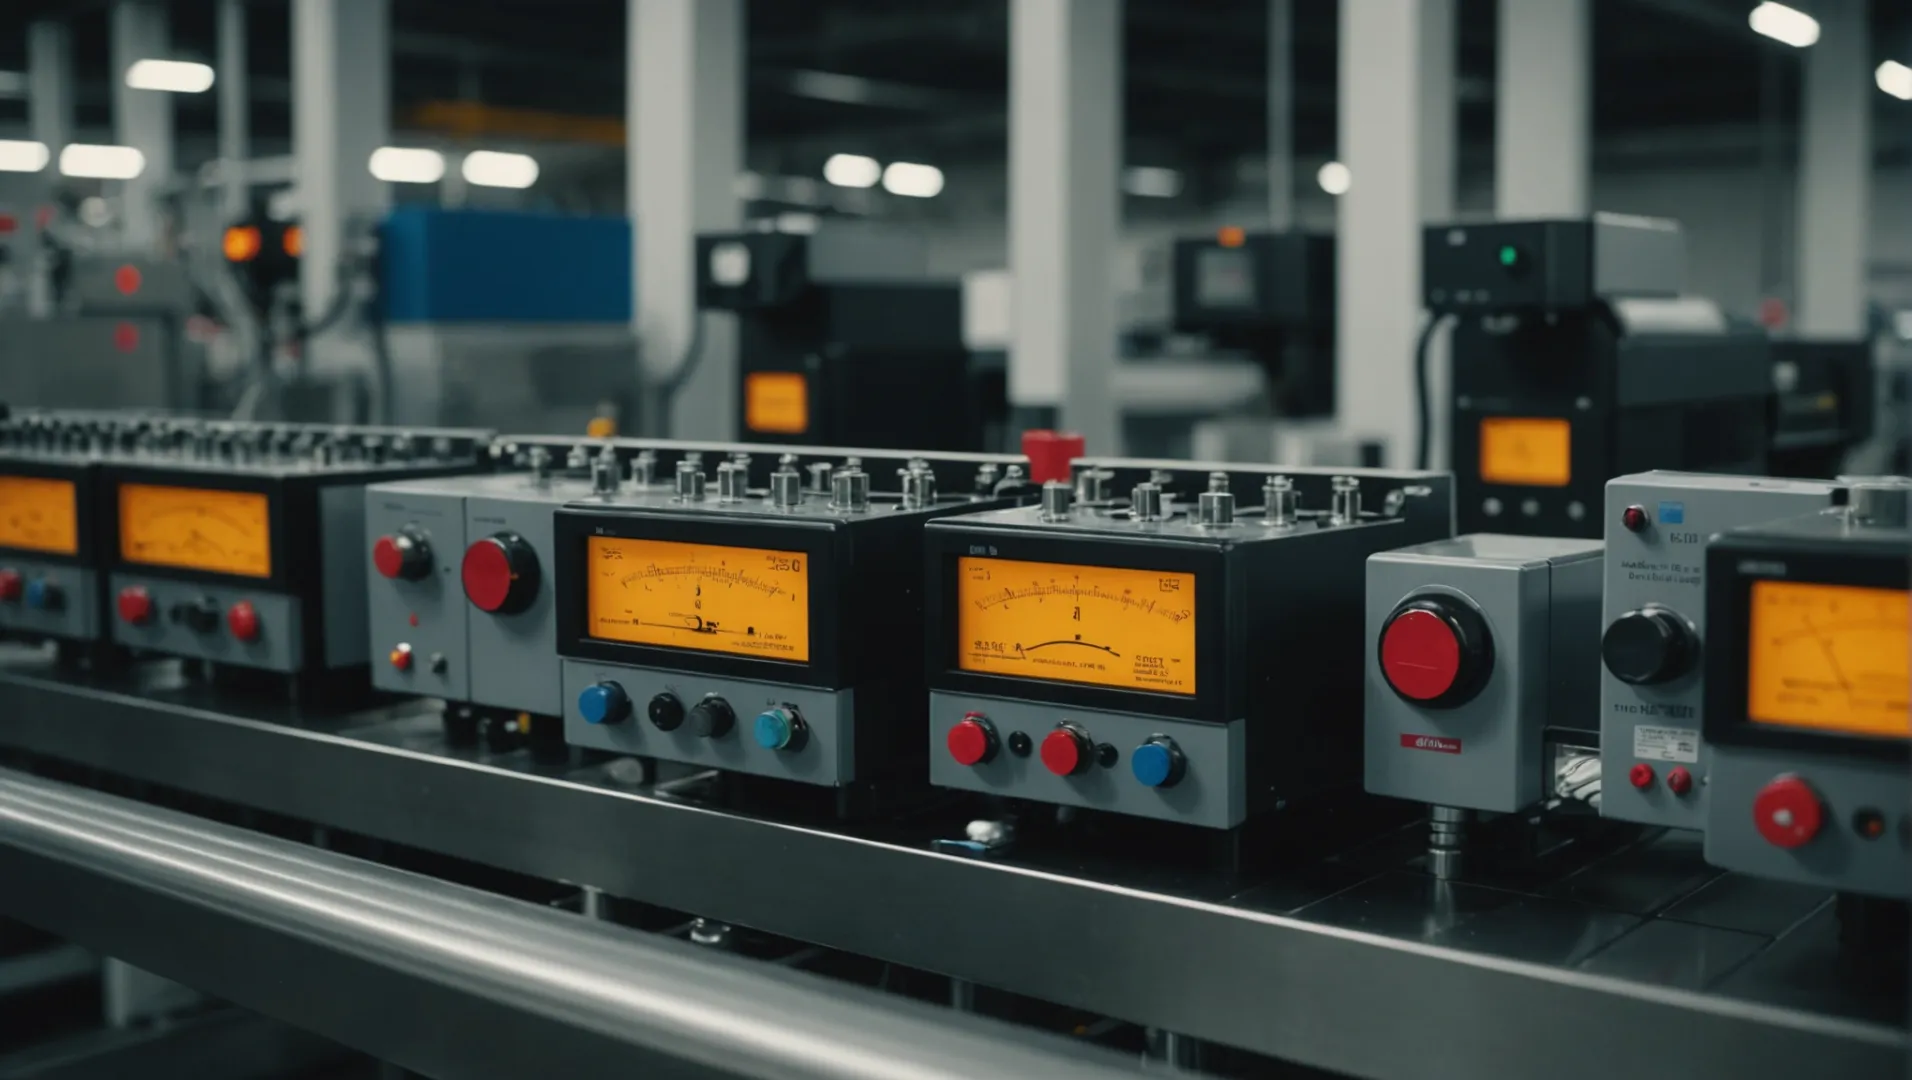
[956,558,1195,694]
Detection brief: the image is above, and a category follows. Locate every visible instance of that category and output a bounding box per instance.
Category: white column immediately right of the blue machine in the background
[625,0,744,440]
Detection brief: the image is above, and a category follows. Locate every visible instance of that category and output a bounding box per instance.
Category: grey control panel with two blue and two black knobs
[564,659,857,788]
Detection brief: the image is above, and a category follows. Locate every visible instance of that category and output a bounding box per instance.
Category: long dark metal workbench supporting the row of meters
[0,654,1908,1080]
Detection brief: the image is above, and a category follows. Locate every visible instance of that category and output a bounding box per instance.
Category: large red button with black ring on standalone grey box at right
[1379,594,1493,709]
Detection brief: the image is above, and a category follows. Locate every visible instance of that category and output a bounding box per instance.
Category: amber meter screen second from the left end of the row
[119,484,272,577]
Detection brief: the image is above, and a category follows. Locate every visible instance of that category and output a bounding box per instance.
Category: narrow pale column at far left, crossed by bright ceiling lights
[109,0,172,250]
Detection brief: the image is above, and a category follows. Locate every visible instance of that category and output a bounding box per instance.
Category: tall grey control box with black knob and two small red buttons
[1600,472,1836,830]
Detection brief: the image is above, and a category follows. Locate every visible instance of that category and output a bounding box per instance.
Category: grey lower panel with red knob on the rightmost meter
[1706,745,1912,898]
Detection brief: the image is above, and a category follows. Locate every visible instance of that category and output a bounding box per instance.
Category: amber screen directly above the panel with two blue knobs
[585,537,811,661]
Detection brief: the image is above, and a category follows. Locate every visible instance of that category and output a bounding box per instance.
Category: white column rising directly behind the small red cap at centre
[1010,0,1122,453]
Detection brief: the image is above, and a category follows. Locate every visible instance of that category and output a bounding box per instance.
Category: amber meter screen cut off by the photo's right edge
[1746,581,1912,738]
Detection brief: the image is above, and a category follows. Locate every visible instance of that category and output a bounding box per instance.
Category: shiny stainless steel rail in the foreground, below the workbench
[0,770,1138,1080]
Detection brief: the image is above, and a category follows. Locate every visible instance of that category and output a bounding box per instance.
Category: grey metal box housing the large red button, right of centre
[1363,533,1602,812]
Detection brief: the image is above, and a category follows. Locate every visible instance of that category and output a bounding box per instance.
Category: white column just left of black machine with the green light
[1335,0,1453,464]
